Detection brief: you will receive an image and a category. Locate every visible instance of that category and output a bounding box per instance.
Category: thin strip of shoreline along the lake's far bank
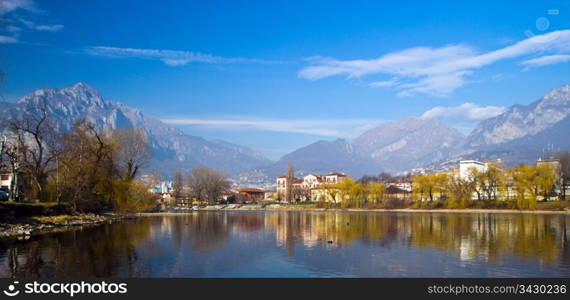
[136,205,570,216]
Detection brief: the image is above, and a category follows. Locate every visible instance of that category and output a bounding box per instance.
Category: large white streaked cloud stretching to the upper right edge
[299,30,570,96]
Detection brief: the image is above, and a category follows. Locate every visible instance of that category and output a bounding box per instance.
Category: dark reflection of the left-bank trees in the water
[0,220,154,277]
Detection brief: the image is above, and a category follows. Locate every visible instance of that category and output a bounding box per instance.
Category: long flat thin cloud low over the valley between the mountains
[162,117,381,138]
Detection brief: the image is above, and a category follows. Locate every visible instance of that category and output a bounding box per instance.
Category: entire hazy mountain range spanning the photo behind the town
[0,83,570,184]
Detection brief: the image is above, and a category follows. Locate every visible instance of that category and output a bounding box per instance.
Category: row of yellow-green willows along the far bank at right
[311,157,570,210]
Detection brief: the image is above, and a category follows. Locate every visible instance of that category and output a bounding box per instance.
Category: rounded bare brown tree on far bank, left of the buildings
[186,167,230,203]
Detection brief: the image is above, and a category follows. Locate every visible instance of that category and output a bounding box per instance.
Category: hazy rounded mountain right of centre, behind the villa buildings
[250,118,465,178]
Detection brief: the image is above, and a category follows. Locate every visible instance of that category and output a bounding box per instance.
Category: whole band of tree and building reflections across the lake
[0,212,570,277]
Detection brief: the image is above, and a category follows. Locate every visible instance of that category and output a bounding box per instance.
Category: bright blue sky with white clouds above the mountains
[0,0,570,159]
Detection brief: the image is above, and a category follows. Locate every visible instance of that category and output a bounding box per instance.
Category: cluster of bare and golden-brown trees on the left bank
[0,103,153,212]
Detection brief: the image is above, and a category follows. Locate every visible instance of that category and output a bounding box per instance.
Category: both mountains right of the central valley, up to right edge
[246,85,570,178]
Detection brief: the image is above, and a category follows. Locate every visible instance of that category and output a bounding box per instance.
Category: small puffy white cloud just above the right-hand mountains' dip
[421,102,505,123]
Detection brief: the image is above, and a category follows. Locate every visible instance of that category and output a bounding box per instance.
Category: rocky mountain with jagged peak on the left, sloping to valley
[0,83,271,175]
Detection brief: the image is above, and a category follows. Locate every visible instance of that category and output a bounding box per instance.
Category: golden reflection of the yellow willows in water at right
[266,212,569,264]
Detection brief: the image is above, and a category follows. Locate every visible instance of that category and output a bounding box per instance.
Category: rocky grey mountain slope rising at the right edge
[457,84,570,165]
